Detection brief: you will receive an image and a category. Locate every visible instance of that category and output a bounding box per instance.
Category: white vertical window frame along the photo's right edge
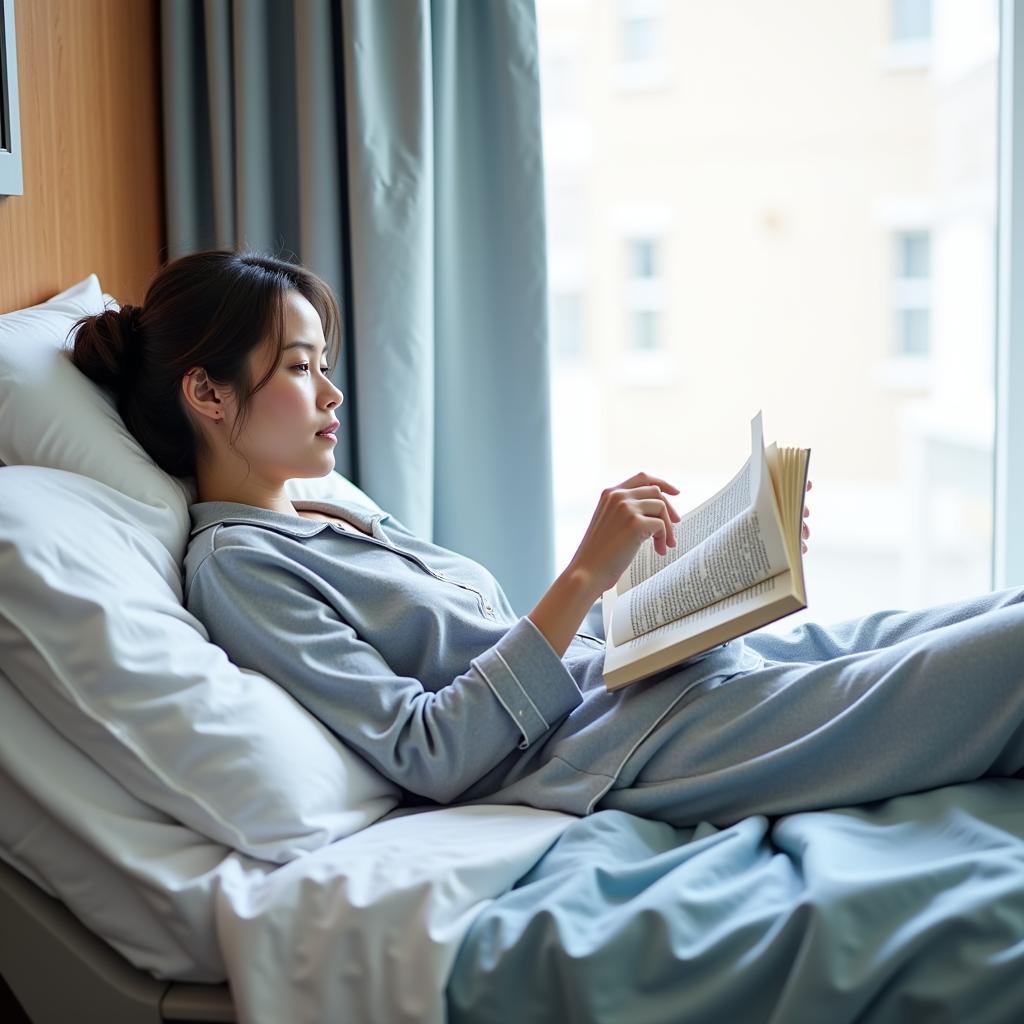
[992,0,1024,590]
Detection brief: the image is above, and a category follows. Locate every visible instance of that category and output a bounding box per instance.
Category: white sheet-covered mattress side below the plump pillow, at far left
[0,672,228,982]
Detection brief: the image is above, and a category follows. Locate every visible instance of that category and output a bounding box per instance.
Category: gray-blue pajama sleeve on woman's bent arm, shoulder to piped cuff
[187,544,583,803]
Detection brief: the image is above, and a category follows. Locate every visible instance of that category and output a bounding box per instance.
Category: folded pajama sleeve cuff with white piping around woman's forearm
[472,615,583,750]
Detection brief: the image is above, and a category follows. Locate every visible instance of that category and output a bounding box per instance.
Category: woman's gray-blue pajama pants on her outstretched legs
[594,588,1024,825]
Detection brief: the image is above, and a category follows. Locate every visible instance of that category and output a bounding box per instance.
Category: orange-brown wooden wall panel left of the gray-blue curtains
[0,0,166,311]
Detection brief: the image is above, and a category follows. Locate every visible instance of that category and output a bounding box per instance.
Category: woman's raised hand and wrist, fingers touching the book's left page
[570,473,682,594]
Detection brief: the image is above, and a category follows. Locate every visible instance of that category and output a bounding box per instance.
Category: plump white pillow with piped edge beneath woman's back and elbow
[0,466,399,862]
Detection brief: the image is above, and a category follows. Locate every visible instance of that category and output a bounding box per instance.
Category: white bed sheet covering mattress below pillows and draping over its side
[0,674,575,1024]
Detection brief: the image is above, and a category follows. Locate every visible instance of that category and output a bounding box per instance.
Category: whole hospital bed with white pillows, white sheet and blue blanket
[0,275,1024,1024]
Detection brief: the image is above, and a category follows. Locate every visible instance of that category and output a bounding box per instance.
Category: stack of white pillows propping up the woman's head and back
[0,274,398,862]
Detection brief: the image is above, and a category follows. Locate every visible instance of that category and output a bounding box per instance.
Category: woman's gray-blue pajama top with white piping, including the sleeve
[184,500,763,814]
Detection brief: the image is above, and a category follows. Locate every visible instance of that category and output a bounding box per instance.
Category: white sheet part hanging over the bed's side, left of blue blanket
[217,805,575,1024]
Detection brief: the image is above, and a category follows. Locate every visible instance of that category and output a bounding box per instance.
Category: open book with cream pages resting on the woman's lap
[601,412,811,690]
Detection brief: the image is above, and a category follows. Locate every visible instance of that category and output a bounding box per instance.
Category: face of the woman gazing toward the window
[224,291,344,487]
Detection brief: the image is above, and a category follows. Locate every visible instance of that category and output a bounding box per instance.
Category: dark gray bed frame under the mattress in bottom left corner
[0,860,237,1024]
